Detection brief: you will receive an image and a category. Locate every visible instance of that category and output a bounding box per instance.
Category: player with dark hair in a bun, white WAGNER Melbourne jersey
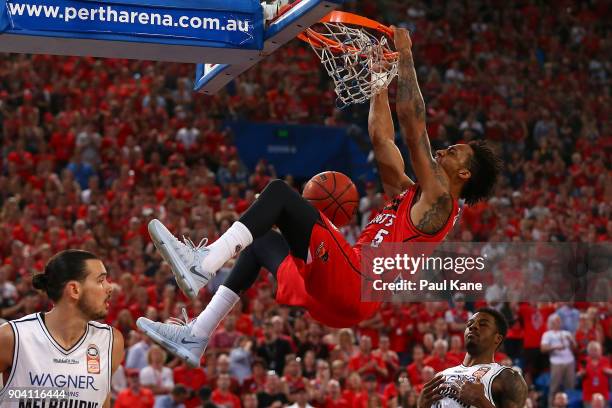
[0,250,123,408]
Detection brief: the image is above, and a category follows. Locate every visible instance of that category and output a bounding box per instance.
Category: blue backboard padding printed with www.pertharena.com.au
[0,0,264,49]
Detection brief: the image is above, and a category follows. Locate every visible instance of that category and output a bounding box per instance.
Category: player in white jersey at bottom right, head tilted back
[418,308,527,408]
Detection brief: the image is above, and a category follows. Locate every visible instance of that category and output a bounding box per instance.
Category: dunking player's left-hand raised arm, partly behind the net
[368,89,414,198]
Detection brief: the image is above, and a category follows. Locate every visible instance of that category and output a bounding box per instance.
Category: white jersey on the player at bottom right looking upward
[432,363,512,408]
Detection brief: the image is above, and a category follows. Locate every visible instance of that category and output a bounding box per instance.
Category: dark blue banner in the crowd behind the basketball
[227,122,375,181]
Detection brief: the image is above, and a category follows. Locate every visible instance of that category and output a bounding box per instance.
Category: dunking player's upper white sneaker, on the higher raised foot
[149,220,214,299]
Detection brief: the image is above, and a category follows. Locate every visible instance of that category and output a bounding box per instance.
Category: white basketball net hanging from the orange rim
[310,23,397,108]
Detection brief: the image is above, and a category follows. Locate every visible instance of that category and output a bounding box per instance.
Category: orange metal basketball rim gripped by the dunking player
[297,11,398,60]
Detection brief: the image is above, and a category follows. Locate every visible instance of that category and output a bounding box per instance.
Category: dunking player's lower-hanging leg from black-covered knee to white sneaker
[136,231,289,366]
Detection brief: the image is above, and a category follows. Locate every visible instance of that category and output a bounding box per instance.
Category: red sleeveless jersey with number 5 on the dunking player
[354,184,459,252]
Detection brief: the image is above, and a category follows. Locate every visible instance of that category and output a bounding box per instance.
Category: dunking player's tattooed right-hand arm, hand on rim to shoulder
[395,28,453,234]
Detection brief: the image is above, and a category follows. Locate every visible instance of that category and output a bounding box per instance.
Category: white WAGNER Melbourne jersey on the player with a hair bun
[0,313,113,408]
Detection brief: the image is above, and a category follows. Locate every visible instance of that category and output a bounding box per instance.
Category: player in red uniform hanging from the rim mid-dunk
[137,29,499,365]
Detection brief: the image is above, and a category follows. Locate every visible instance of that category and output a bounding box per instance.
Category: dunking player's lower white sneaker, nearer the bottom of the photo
[136,311,208,367]
